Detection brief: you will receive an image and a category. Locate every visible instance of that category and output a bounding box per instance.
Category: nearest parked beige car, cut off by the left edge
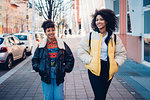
[0,35,26,69]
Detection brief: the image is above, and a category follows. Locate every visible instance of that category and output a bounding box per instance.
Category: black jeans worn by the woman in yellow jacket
[88,60,111,100]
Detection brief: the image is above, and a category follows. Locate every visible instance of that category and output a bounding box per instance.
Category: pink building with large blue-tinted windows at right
[105,0,150,66]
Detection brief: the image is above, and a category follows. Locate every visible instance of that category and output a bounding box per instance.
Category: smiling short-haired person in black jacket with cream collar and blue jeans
[32,20,74,100]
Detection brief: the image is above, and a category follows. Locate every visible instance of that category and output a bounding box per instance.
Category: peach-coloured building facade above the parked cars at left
[0,0,27,34]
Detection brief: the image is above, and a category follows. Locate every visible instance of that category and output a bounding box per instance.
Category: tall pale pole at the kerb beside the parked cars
[32,0,35,56]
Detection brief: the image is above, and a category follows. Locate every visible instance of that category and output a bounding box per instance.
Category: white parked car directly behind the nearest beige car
[14,33,33,54]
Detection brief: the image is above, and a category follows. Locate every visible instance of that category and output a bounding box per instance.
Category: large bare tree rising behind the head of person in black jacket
[36,0,71,37]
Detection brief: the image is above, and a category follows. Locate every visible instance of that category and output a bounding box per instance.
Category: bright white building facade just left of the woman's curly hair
[79,0,105,34]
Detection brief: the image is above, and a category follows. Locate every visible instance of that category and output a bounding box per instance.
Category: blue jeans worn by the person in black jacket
[42,67,64,100]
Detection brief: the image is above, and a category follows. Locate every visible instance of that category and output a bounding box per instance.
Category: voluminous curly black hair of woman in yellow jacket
[91,9,118,32]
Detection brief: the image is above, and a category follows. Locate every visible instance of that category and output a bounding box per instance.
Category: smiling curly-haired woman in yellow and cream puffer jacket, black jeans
[78,9,127,100]
